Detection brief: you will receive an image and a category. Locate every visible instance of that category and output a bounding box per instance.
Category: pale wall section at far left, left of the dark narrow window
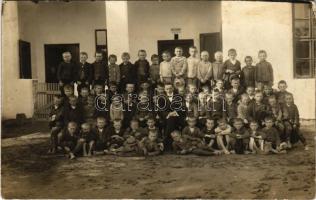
[1,1,33,120]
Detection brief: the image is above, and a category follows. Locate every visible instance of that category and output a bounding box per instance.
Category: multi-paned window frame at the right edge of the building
[292,3,316,79]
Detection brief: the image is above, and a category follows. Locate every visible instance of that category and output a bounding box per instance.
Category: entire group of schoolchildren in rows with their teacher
[49,47,308,159]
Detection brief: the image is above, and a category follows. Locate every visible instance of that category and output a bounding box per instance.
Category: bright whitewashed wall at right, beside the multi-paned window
[222,1,315,119]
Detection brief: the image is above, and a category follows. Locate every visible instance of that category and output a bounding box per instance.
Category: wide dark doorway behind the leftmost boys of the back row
[44,44,80,83]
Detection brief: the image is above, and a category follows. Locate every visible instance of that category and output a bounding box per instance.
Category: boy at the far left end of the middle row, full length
[48,95,63,154]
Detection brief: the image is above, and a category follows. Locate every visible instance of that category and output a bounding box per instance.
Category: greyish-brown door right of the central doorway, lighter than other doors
[200,32,222,62]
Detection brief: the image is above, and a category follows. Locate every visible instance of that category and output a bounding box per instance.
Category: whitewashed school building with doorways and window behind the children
[1,0,316,119]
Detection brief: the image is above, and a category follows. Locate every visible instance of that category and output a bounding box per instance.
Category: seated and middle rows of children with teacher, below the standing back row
[49,76,308,158]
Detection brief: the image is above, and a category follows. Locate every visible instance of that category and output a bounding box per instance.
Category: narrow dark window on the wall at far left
[19,40,32,79]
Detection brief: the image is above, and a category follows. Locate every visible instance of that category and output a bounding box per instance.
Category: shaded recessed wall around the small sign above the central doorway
[128,1,221,60]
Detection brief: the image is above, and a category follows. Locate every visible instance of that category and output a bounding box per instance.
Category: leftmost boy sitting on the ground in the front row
[58,122,83,159]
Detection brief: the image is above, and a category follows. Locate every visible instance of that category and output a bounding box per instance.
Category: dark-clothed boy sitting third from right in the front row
[229,118,249,154]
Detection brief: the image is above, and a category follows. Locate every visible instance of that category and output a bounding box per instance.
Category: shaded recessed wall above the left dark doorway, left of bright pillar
[18,1,106,82]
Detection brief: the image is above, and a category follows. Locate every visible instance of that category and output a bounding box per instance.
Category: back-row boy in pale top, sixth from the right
[186,46,200,85]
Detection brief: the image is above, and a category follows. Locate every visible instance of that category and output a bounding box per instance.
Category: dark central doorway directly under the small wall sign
[158,40,194,61]
